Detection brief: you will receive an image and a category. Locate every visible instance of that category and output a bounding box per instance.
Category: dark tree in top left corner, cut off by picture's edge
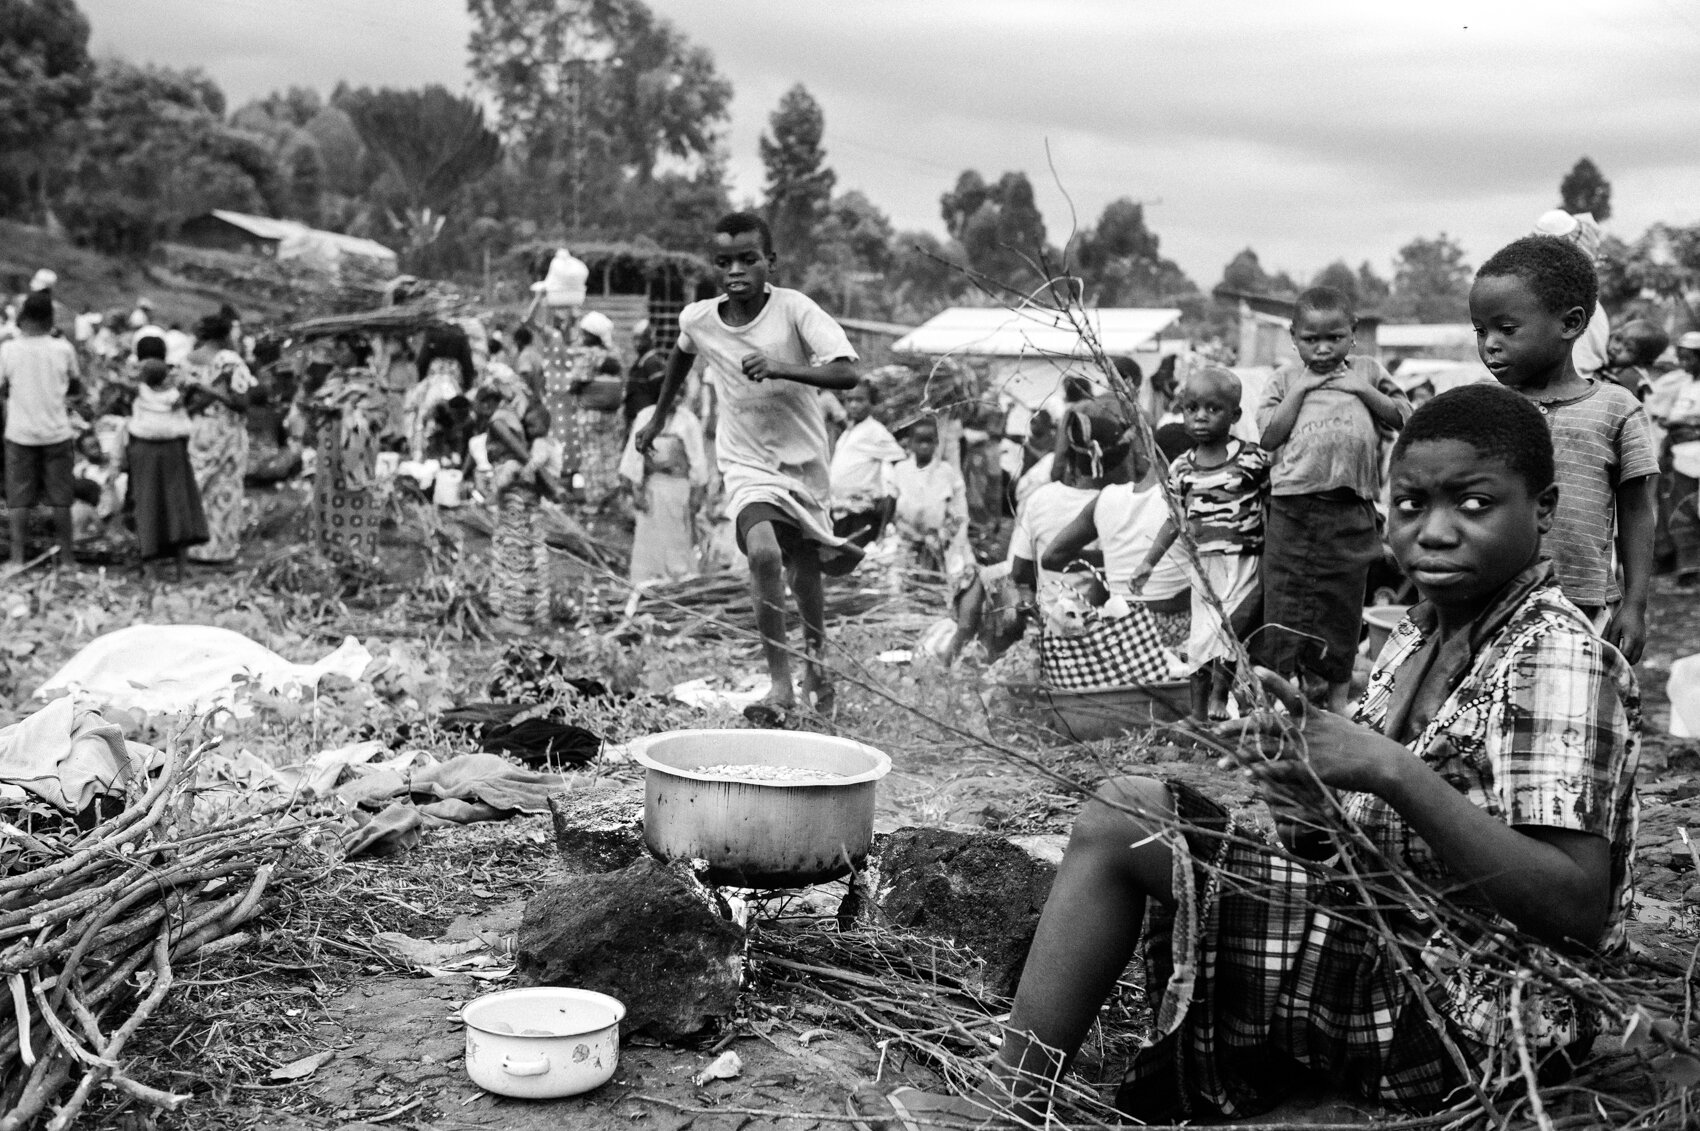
[0,0,94,209]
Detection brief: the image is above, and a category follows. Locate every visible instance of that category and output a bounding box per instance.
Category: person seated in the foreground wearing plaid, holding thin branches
[881,384,1639,1122]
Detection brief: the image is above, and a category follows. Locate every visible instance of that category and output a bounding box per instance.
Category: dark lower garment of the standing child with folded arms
[1251,490,1380,684]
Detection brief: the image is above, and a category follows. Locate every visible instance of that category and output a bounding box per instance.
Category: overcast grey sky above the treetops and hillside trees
[82,0,1700,287]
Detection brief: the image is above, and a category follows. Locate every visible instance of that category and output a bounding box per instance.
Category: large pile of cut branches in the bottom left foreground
[0,742,315,1131]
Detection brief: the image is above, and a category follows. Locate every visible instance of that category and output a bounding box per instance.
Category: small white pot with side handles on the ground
[461,986,626,1100]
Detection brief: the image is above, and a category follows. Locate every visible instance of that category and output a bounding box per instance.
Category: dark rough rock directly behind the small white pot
[517,855,745,1041]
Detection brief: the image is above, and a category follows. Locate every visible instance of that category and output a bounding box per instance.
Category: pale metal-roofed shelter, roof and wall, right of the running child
[891,306,1185,408]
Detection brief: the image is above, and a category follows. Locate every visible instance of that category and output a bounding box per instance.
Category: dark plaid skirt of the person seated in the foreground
[1115,782,1593,1122]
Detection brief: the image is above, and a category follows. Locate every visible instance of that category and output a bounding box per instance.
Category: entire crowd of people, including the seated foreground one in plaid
[0,196,1700,1122]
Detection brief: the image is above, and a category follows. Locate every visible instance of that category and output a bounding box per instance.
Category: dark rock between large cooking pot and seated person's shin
[877,828,1056,995]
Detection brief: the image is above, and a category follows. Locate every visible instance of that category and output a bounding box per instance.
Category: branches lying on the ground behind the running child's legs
[627,573,950,639]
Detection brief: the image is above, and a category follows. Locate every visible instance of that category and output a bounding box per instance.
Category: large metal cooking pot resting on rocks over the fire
[632,730,891,888]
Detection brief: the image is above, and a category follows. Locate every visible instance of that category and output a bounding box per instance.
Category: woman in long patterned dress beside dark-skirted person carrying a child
[184,313,253,565]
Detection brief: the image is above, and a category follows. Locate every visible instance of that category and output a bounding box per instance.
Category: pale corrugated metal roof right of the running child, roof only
[891,306,1180,357]
